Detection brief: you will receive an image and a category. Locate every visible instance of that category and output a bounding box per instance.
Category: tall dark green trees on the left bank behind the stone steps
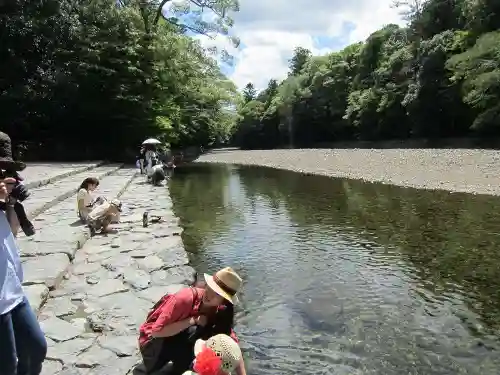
[0,0,240,160]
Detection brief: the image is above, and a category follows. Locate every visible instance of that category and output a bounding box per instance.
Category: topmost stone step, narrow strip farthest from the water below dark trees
[21,161,104,189]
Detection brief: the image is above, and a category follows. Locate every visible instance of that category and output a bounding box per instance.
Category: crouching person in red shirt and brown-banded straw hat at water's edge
[139,267,246,375]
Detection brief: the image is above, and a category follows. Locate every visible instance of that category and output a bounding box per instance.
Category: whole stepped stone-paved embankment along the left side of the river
[14,163,194,375]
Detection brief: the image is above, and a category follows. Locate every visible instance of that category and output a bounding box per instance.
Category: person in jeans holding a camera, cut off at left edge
[0,132,47,375]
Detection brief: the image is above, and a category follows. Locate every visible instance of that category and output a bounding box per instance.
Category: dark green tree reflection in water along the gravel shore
[236,167,500,334]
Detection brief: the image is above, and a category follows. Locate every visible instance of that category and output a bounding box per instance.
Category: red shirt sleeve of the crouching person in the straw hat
[151,288,194,332]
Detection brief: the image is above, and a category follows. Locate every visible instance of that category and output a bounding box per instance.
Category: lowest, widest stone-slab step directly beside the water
[39,177,194,375]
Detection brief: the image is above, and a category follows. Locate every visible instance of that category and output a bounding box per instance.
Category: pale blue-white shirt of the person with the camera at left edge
[0,211,24,315]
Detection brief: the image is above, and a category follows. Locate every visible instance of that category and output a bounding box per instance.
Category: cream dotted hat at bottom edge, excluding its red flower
[194,334,242,374]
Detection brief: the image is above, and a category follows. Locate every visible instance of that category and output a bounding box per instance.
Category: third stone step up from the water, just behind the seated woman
[23,164,123,218]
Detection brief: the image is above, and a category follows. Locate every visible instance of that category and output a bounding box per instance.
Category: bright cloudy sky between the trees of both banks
[173,0,403,90]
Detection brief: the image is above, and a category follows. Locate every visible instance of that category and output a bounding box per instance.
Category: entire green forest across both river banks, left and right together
[0,0,500,160]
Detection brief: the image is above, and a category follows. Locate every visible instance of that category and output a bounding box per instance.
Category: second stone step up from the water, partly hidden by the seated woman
[18,169,136,311]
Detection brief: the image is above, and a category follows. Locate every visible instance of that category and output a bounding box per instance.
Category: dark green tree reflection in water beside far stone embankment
[169,166,242,262]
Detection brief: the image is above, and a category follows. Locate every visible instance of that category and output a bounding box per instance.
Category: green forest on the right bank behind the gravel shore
[233,0,500,149]
